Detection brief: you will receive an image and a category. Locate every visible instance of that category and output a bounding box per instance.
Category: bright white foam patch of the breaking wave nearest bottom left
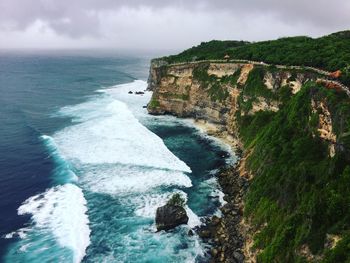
[18,184,90,262]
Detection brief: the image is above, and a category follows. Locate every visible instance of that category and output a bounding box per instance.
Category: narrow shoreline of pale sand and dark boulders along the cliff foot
[191,119,255,263]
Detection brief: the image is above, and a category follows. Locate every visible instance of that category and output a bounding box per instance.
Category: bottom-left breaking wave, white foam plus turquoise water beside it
[5,184,90,263]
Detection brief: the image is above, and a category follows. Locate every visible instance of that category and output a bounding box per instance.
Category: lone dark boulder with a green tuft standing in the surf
[156,193,188,231]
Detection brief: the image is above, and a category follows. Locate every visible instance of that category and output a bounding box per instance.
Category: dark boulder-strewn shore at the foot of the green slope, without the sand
[198,152,248,263]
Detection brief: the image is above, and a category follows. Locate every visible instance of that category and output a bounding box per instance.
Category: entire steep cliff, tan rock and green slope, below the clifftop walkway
[148,60,350,262]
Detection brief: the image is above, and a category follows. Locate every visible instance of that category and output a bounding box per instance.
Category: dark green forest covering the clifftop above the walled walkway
[161,31,350,84]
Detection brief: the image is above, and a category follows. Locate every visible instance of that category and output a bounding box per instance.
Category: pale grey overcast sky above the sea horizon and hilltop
[0,0,350,50]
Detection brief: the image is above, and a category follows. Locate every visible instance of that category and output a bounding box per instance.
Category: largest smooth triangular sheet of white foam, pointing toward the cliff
[53,98,191,172]
